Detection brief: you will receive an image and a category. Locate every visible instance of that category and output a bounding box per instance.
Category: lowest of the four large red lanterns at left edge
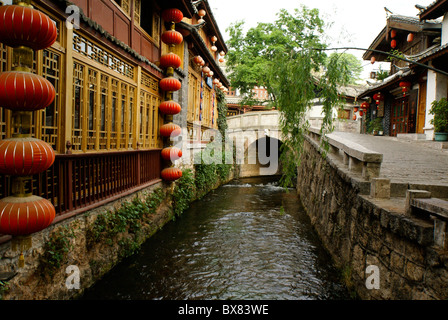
[0,196,56,236]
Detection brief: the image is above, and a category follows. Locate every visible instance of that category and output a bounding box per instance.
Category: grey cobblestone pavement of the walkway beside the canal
[333,132,448,185]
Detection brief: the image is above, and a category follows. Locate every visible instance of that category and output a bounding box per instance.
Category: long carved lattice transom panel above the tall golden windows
[73,33,135,79]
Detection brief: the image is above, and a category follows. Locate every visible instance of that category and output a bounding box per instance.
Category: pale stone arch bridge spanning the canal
[227,111,284,177]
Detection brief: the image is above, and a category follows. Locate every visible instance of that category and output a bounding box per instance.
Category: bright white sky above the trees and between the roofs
[208,0,434,81]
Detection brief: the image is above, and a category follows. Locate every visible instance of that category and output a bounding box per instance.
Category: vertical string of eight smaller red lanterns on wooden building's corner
[159,8,183,181]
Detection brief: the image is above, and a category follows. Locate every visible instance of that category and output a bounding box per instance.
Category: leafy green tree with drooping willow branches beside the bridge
[227,6,351,186]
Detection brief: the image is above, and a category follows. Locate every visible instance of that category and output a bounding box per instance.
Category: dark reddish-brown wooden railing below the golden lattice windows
[0,149,161,220]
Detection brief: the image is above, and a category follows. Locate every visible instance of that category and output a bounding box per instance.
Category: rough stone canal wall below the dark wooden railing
[0,183,172,300]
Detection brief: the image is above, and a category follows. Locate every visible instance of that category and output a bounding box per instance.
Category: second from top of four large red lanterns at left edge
[0,71,56,111]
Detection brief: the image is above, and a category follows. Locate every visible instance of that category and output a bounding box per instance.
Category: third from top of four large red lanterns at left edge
[0,138,55,176]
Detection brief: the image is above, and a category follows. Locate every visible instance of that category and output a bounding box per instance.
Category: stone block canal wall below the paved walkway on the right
[297,139,448,300]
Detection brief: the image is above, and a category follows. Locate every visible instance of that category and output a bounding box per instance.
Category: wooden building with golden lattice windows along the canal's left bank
[0,0,229,241]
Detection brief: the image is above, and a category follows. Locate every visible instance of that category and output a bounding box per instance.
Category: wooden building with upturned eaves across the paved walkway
[359,15,442,136]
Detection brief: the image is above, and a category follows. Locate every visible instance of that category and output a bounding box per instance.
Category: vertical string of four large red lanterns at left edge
[0,0,57,267]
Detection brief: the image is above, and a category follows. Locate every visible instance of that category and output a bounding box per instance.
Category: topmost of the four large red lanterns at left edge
[0,5,58,51]
